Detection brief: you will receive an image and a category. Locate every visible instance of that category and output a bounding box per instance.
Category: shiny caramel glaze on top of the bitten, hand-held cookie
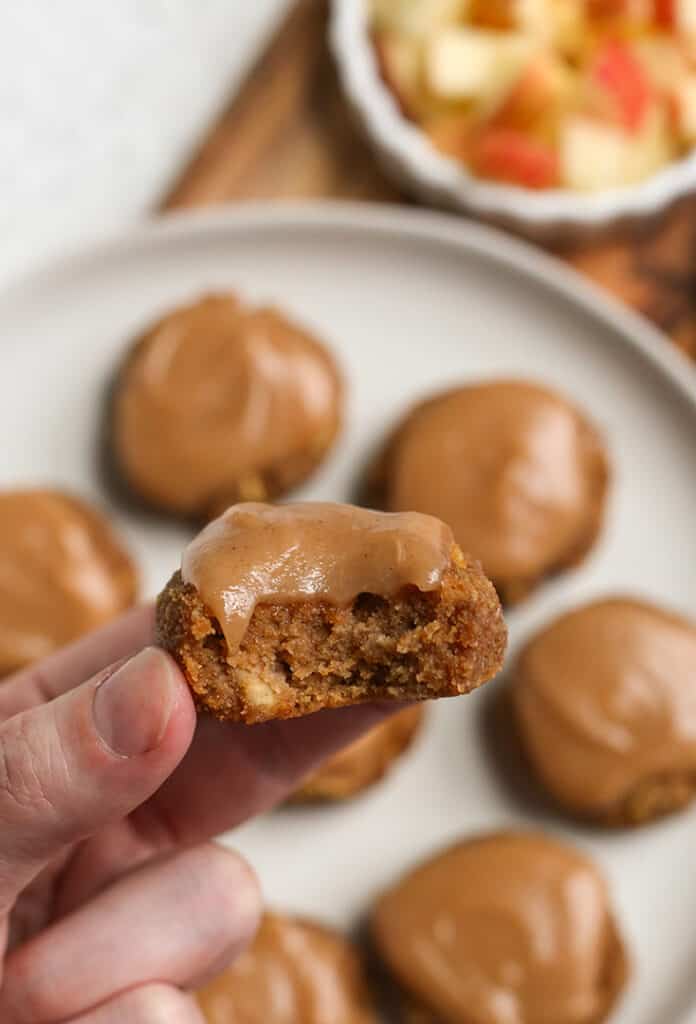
[181,502,453,651]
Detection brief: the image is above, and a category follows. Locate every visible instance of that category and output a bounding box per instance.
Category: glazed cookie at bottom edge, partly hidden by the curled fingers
[198,913,378,1024]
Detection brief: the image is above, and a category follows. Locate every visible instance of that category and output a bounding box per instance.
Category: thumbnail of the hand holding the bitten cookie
[92,647,176,758]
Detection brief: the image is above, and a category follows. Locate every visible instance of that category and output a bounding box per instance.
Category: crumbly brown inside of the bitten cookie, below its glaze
[157,549,507,724]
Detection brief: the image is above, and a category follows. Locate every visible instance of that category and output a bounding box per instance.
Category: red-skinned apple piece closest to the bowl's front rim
[471,128,559,188]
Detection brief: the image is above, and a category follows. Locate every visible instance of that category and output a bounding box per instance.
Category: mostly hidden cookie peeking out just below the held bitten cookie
[293,705,425,803]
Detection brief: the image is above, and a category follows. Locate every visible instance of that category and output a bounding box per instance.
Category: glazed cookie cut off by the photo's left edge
[0,489,137,676]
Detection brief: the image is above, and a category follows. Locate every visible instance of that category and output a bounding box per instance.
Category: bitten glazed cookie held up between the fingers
[158,503,506,722]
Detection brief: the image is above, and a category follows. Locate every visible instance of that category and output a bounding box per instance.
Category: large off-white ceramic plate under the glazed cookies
[0,204,696,1024]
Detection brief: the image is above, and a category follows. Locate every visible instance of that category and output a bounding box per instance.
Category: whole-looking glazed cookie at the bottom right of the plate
[372,833,627,1024]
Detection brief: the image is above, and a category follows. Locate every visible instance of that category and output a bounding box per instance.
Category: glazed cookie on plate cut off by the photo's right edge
[509,598,696,824]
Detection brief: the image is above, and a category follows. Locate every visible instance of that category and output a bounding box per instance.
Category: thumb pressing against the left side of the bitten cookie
[0,647,195,913]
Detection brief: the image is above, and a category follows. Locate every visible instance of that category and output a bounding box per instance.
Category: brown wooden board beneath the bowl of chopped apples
[164,0,696,359]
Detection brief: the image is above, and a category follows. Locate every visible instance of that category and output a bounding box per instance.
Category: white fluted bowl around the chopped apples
[330,0,696,237]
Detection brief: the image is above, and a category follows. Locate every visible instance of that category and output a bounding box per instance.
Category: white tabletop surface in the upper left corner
[0,0,288,287]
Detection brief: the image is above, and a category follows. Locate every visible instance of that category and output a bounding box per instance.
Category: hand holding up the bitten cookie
[0,608,387,1024]
